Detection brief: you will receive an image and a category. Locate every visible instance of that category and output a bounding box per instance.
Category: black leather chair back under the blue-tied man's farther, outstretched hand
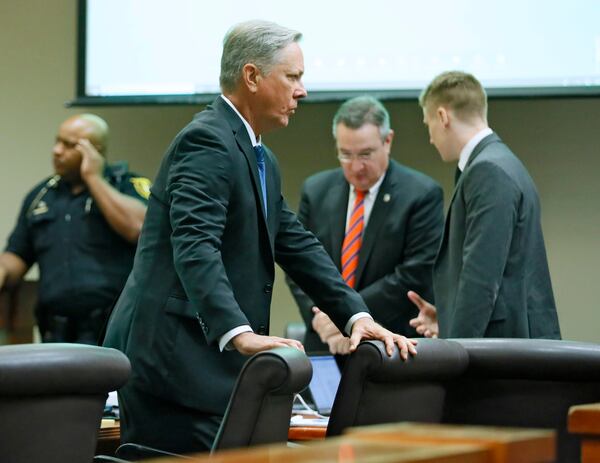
[327,339,468,436]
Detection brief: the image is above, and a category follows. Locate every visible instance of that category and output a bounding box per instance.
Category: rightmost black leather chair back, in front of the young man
[442,339,600,462]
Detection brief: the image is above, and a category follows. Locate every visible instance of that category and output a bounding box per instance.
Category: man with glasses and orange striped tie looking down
[287,96,444,354]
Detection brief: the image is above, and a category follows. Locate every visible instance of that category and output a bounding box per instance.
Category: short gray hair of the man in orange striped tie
[333,95,390,140]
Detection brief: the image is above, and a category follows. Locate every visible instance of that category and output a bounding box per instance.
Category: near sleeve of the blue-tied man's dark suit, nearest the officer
[166,129,250,343]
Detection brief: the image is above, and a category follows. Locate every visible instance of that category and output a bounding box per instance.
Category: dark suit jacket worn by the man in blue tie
[104,98,368,414]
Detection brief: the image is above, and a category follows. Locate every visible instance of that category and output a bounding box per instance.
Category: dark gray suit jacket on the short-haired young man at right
[434,134,560,338]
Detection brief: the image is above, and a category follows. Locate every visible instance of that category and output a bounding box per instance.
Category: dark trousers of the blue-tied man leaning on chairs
[118,384,223,454]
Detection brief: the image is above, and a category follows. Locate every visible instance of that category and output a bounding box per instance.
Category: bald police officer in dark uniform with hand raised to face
[0,114,150,344]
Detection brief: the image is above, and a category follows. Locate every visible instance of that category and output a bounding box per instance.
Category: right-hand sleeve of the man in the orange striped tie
[360,185,444,334]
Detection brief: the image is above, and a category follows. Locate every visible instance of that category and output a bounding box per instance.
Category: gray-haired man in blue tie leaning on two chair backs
[105,21,415,453]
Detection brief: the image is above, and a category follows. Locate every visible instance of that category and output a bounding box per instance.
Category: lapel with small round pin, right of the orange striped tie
[355,160,396,288]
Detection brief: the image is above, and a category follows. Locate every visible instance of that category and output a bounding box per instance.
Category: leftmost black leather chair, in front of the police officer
[0,344,130,463]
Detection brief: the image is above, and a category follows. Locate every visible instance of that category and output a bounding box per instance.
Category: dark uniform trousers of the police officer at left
[39,309,109,345]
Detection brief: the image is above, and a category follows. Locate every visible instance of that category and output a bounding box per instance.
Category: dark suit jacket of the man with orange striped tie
[288,160,444,350]
